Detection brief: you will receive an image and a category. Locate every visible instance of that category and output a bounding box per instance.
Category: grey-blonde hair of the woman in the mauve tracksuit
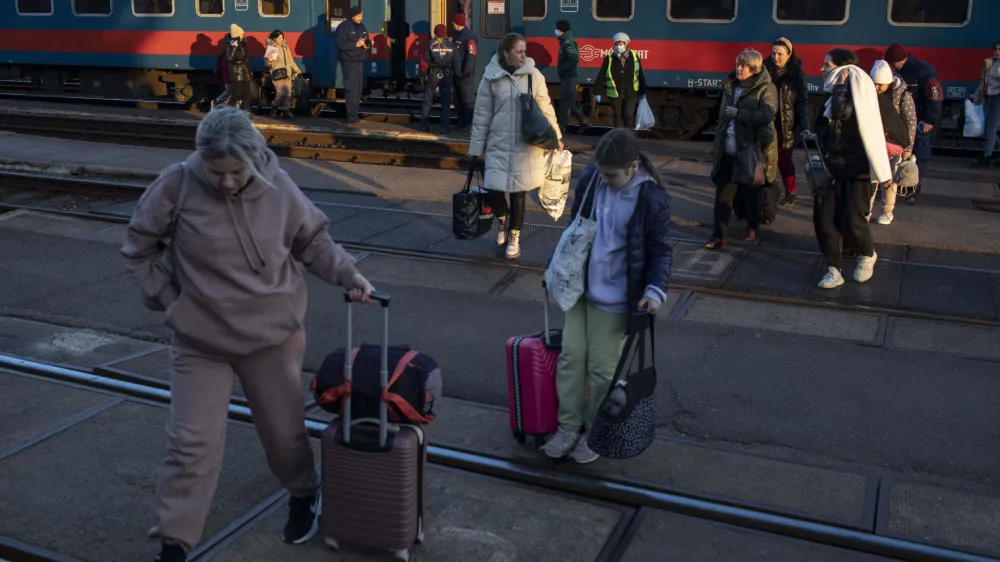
[195,105,274,189]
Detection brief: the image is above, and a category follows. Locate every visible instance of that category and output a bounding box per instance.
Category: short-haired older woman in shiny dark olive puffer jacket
[705,49,778,250]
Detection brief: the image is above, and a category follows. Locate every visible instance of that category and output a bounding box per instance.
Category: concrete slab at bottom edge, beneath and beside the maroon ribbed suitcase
[203,467,632,562]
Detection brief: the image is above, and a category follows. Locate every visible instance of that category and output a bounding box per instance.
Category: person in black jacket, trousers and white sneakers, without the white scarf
[813,49,888,289]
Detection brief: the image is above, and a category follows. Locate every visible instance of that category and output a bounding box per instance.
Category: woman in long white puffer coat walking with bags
[469,33,564,260]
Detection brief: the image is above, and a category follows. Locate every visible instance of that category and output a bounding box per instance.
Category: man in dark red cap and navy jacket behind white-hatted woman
[885,43,944,205]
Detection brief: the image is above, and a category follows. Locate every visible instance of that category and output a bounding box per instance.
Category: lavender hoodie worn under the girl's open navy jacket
[587,168,666,314]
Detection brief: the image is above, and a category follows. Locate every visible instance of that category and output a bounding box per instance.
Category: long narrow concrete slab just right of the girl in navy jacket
[682,295,879,343]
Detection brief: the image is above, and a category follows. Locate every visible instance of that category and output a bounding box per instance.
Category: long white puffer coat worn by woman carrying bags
[469,55,562,193]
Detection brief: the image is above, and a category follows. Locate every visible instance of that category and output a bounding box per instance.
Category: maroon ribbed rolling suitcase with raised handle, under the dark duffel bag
[320,293,427,561]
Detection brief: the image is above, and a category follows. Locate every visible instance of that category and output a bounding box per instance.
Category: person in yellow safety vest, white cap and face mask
[594,33,646,129]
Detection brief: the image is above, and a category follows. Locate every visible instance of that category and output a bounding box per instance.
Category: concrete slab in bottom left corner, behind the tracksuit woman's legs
[0,390,280,561]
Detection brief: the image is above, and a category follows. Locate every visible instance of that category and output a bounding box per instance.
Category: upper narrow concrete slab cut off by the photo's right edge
[888,318,1000,361]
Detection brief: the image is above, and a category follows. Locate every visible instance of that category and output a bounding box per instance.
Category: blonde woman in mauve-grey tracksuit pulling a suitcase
[121,106,373,562]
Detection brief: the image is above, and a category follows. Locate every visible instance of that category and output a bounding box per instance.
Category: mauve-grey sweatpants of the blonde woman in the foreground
[150,331,319,552]
